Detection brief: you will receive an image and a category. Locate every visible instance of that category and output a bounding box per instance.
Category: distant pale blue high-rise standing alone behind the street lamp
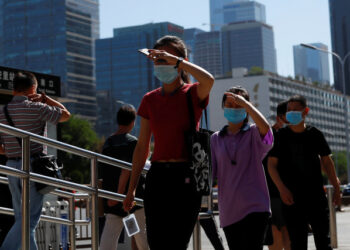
[293,43,330,85]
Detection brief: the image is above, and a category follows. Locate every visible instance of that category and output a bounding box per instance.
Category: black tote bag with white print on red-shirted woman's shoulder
[185,88,212,195]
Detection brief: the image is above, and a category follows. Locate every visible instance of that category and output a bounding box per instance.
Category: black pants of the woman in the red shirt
[144,163,201,250]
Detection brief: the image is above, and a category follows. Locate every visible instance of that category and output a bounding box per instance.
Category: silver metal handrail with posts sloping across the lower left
[0,124,147,250]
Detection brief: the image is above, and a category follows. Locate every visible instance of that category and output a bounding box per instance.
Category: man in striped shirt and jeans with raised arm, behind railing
[0,72,70,250]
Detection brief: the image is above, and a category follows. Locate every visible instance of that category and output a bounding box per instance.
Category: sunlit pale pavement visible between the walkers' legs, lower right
[188,206,350,250]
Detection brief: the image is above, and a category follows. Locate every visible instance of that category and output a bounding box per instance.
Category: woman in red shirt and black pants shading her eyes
[124,36,214,250]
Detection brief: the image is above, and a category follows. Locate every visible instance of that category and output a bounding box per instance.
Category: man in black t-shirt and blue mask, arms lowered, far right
[268,96,340,250]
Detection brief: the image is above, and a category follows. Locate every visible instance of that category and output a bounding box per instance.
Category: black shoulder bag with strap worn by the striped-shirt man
[4,105,63,194]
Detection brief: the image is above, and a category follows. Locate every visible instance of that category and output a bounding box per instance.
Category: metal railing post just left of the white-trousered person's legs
[91,157,98,250]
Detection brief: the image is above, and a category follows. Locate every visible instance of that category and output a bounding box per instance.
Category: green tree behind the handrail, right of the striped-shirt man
[58,115,102,183]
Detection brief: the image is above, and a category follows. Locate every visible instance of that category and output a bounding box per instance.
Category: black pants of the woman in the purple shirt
[223,212,270,250]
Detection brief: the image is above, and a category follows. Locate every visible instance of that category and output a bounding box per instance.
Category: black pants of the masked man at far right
[283,197,332,250]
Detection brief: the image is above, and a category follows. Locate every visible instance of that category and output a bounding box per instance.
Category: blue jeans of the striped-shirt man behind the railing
[0,160,44,250]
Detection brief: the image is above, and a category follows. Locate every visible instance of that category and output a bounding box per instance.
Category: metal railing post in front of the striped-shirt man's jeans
[22,136,30,249]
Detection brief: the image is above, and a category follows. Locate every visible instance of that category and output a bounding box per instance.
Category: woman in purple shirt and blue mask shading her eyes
[211,87,273,250]
